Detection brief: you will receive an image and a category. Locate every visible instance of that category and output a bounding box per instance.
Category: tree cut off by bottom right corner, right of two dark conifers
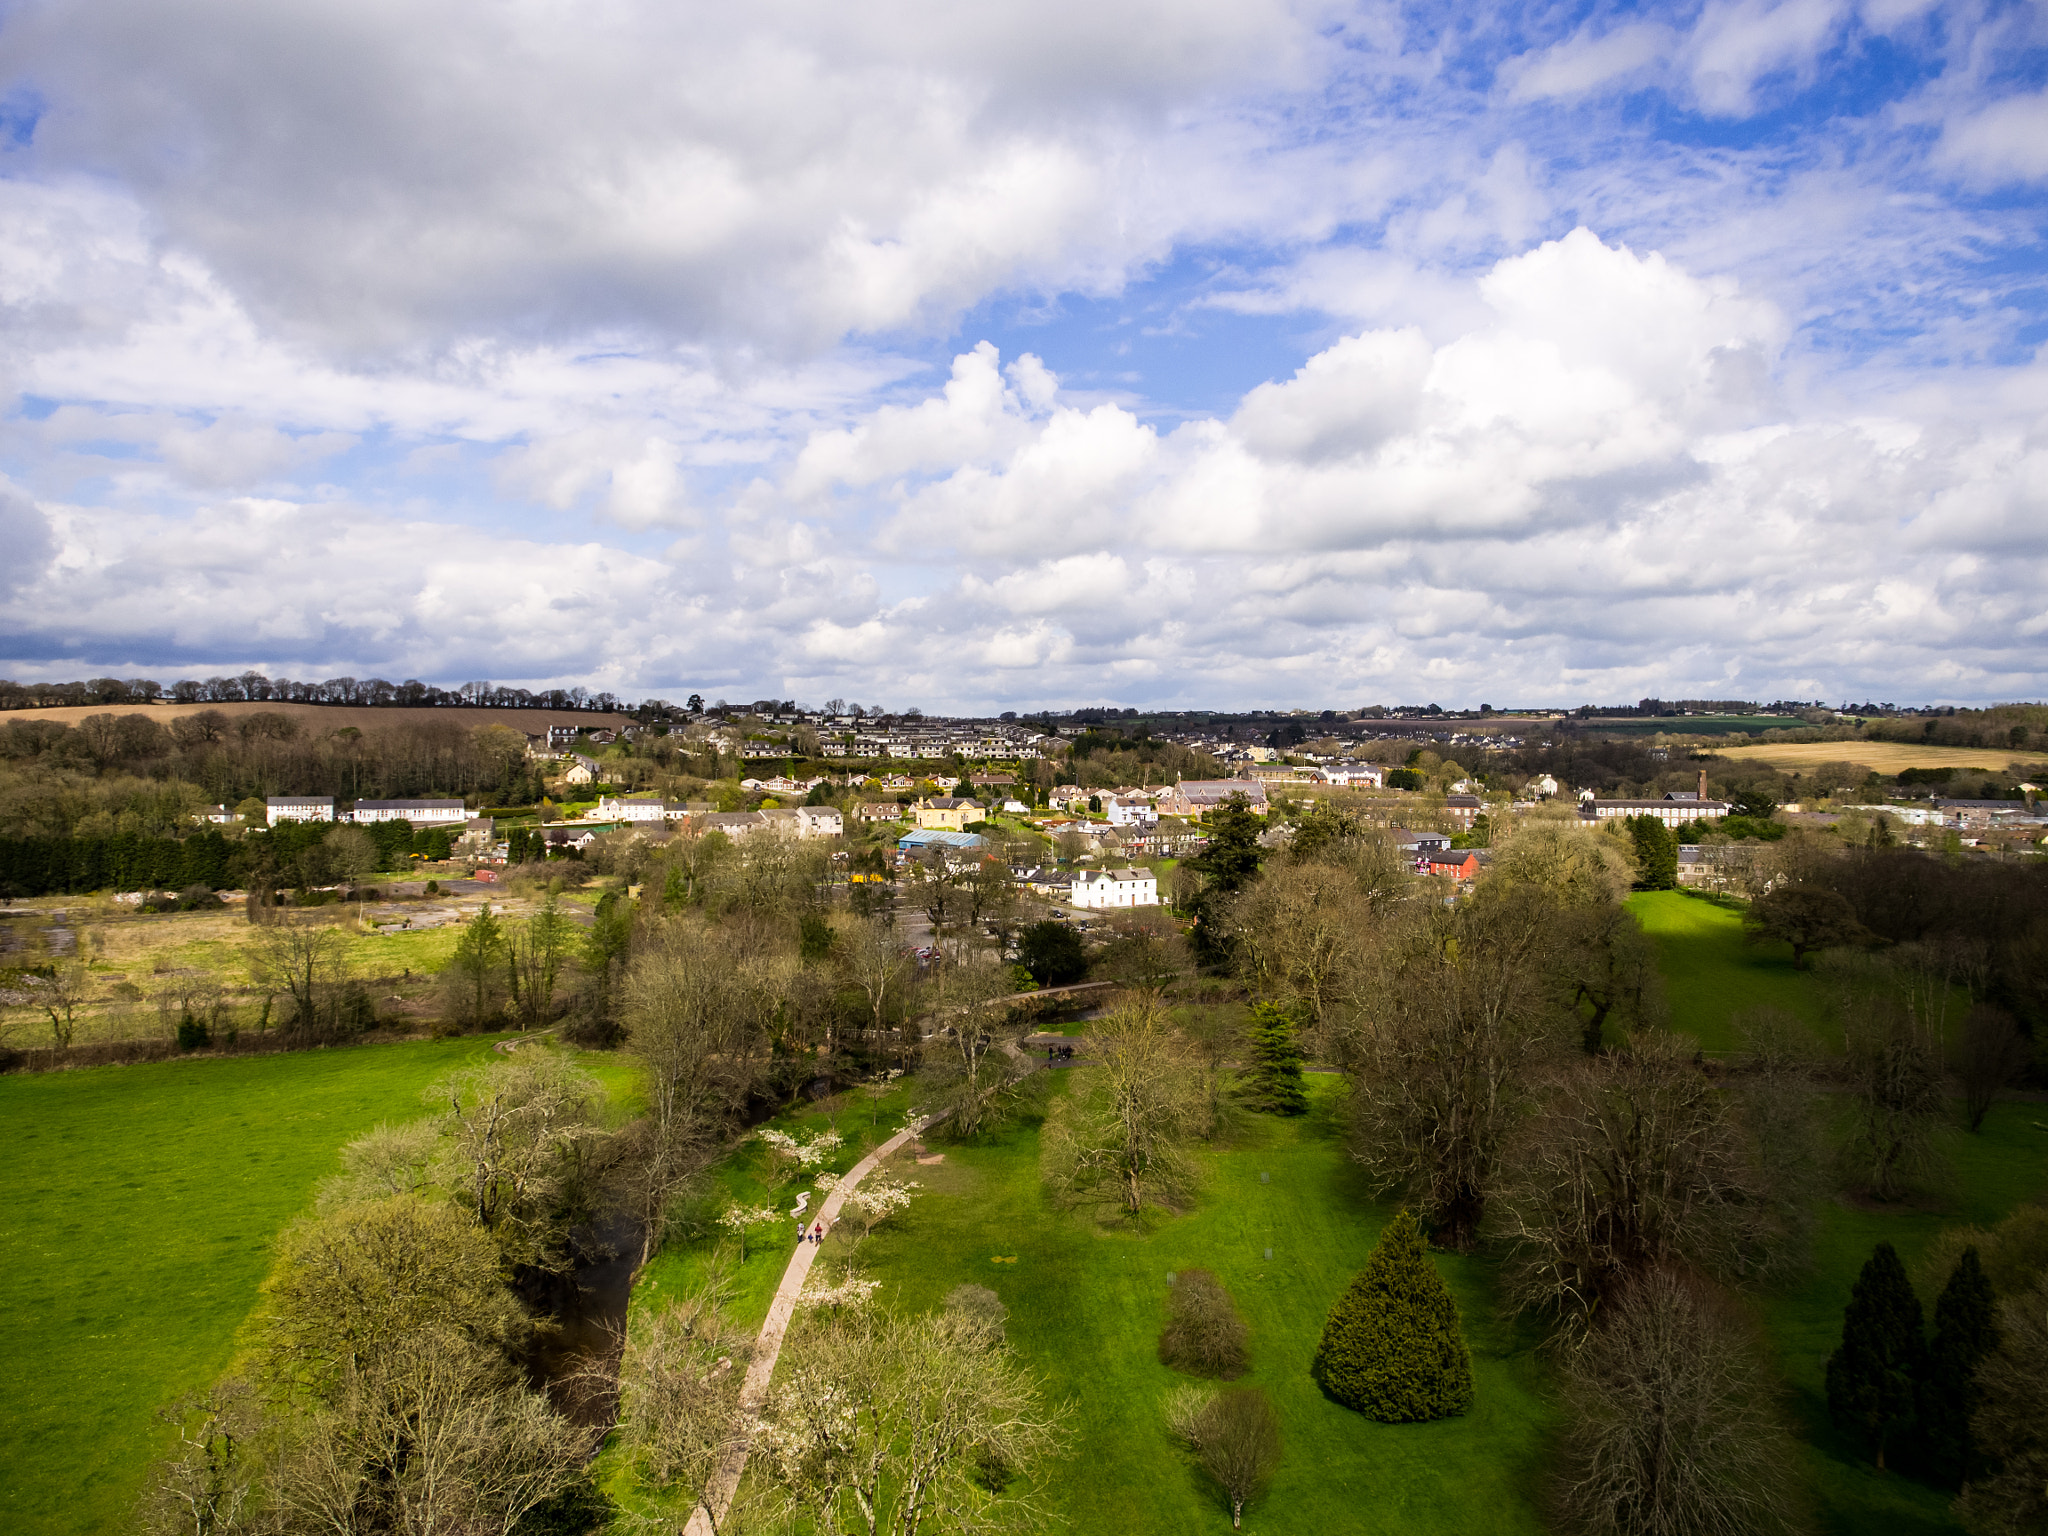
[1960,1278,2048,1536]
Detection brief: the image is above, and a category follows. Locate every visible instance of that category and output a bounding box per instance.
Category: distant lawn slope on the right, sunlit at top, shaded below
[1628,891,1823,1055]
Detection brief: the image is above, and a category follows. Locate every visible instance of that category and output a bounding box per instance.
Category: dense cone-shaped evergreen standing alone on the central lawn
[1309,1210,1473,1423]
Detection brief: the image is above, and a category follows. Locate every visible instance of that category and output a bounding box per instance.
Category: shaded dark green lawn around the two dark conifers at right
[1757,1104,2048,1536]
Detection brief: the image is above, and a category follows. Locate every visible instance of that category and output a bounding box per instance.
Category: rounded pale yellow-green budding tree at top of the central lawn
[1040,993,1200,1219]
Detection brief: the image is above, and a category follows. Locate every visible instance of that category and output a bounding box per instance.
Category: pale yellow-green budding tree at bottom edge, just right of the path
[756,1307,1067,1536]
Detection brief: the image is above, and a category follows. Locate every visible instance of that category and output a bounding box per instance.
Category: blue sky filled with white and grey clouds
[0,0,2048,713]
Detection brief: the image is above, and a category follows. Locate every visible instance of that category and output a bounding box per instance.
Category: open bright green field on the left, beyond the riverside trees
[0,1036,639,1536]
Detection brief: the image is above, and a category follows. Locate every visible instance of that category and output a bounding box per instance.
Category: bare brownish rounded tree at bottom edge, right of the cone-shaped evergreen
[1561,1270,1794,1536]
